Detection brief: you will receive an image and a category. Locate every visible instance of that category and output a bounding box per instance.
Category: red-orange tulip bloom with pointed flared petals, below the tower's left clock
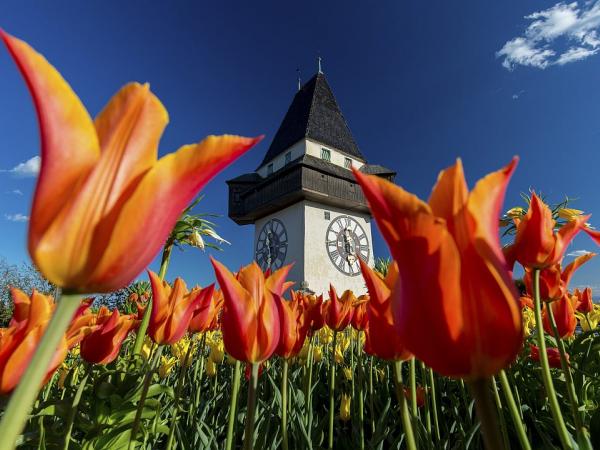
[211,258,291,363]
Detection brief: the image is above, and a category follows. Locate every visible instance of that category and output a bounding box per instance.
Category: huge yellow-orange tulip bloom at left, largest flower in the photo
[0,31,260,293]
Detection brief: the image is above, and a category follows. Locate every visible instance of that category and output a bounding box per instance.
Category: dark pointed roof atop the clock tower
[261,73,365,166]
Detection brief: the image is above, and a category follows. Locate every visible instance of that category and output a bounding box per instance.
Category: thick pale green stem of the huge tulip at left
[0,293,81,450]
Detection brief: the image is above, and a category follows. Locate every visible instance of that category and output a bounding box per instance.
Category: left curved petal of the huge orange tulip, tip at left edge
[0,30,100,254]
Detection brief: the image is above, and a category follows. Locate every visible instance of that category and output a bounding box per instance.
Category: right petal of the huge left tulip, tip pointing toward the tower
[88,136,261,291]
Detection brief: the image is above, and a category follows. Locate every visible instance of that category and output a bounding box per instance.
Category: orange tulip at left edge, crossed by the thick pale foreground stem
[0,288,89,395]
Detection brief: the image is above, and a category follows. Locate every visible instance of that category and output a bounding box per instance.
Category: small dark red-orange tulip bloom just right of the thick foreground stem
[81,306,138,364]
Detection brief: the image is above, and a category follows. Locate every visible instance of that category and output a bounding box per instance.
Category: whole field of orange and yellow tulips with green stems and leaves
[0,30,600,450]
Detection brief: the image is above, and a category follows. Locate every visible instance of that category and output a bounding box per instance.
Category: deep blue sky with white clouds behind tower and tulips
[0,0,600,289]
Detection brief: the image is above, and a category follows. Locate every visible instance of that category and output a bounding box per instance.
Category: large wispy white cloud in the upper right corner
[496,0,600,70]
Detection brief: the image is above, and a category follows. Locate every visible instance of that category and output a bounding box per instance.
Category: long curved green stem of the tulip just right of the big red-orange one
[533,269,573,449]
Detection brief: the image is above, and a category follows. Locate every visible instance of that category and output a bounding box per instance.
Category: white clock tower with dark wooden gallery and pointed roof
[227,70,396,295]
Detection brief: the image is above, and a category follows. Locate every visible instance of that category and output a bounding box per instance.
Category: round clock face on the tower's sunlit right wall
[325,216,370,276]
